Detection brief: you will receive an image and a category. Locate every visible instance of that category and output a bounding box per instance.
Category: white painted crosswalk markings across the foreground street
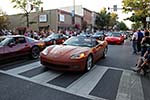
[0,61,144,100]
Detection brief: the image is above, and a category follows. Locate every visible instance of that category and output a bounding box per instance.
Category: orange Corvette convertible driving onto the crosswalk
[40,36,108,71]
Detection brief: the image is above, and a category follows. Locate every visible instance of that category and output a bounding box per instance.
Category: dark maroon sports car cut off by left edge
[0,35,45,61]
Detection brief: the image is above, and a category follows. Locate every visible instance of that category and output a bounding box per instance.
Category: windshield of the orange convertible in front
[63,36,94,47]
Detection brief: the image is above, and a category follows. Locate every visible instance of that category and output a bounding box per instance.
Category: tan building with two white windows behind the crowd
[8,9,82,34]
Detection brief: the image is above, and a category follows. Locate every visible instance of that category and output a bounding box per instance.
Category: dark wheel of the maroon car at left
[31,46,40,59]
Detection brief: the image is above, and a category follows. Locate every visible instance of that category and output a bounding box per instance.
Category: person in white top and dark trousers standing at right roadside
[132,30,138,54]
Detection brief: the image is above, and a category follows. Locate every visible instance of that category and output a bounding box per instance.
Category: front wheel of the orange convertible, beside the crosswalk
[85,55,93,72]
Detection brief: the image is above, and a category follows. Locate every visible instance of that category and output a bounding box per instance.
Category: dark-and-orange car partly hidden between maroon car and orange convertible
[43,33,69,46]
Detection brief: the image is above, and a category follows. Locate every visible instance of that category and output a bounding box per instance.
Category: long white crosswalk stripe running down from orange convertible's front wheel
[67,66,108,95]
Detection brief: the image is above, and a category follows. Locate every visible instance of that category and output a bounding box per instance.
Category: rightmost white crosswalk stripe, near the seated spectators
[116,70,144,100]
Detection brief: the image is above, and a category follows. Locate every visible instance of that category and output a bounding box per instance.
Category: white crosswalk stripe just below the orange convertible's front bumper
[31,70,62,83]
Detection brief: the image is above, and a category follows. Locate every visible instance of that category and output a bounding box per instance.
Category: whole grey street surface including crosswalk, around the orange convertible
[0,41,150,100]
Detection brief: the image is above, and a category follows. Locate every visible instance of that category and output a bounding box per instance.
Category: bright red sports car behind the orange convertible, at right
[105,32,124,44]
